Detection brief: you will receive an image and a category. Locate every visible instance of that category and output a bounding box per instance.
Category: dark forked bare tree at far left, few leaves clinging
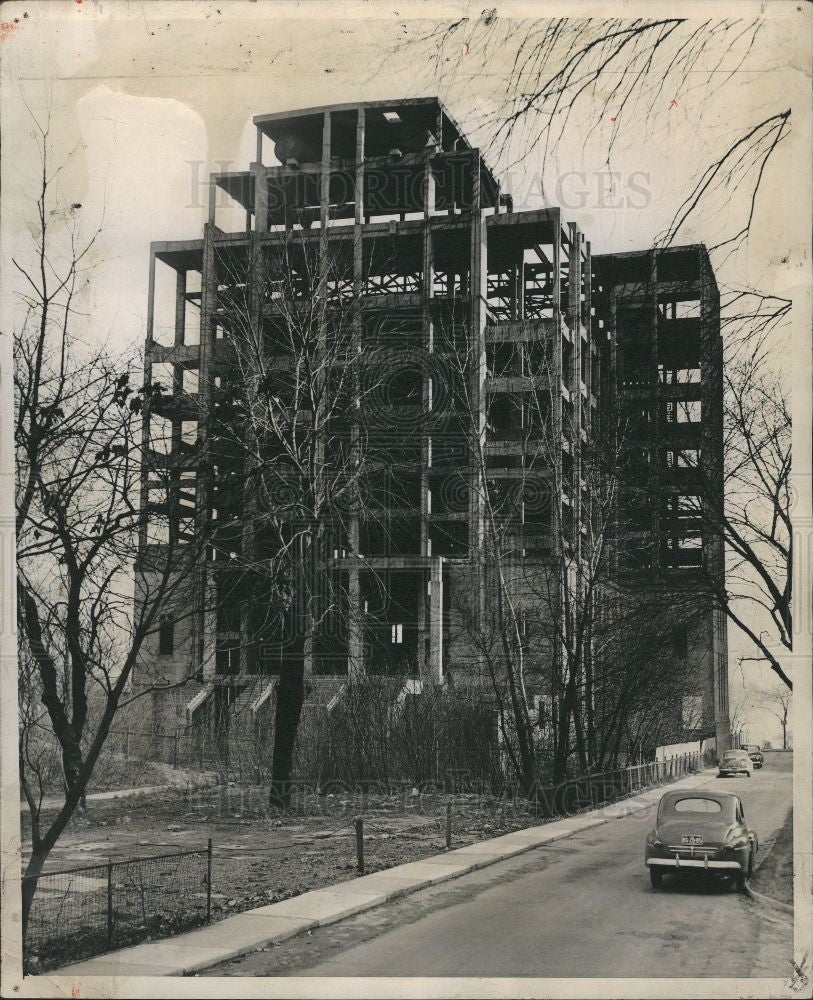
[13,123,206,927]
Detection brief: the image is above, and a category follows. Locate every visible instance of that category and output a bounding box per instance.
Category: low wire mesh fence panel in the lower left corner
[22,840,212,969]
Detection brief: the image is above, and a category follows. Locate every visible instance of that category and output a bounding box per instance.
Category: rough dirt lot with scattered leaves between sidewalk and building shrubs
[23,786,538,969]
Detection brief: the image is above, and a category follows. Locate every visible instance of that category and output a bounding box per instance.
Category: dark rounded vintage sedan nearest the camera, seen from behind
[644,788,759,891]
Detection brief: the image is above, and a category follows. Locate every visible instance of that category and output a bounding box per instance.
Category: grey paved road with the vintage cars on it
[207,754,793,977]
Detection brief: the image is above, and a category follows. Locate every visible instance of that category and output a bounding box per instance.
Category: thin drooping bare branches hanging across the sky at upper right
[386,15,790,253]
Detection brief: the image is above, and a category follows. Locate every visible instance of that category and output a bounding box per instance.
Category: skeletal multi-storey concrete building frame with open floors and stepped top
[137,98,728,746]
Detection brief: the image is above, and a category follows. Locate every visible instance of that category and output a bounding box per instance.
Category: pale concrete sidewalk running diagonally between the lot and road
[58,771,715,977]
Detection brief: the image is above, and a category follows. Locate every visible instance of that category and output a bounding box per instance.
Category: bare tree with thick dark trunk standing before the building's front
[199,228,389,805]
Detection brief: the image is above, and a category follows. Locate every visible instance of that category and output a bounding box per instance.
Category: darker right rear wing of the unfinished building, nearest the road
[595,245,730,749]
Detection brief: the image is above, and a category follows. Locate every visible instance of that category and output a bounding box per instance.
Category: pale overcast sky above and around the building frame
[0,0,810,738]
